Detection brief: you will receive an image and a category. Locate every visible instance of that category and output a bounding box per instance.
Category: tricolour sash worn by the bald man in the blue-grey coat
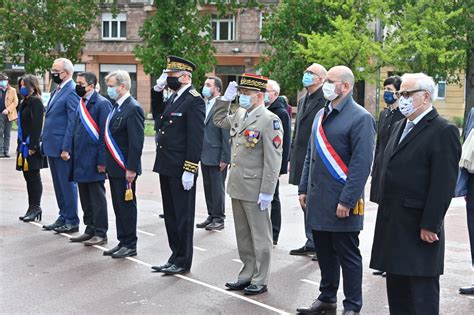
[313,112,348,184]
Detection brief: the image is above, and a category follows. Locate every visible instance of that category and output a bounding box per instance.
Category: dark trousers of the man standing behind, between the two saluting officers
[201,164,227,222]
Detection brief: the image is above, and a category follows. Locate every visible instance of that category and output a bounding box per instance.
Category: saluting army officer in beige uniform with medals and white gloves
[214,74,283,294]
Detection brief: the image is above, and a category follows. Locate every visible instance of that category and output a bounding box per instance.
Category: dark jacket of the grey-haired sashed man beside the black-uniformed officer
[105,96,145,178]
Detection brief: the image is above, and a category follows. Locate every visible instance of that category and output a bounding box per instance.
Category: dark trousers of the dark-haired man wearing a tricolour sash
[77,181,109,237]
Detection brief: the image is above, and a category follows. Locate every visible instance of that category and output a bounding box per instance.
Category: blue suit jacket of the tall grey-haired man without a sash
[42,80,79,157]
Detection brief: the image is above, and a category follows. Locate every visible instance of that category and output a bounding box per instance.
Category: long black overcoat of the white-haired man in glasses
[370,109,461,277]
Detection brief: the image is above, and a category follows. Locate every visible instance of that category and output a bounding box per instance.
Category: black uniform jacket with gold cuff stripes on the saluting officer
[153,86,206,177]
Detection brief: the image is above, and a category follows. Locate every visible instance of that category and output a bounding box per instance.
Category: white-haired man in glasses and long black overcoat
[370,73,461,314]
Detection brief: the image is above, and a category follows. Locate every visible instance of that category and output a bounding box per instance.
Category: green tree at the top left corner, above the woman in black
[0,0,114,73]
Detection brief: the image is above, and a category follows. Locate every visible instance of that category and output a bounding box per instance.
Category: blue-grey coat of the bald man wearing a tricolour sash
[298,95,375,232]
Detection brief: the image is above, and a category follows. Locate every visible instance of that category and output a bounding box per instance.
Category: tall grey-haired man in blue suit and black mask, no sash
[42,58,79,233]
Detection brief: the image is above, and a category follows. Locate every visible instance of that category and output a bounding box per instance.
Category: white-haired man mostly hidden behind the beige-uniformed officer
[265,80,291,245]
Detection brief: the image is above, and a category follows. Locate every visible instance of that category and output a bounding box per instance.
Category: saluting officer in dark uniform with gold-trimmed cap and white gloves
[152,56,206,274]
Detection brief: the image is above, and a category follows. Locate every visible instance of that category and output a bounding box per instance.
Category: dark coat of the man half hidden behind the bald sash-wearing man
[289,88,326,185]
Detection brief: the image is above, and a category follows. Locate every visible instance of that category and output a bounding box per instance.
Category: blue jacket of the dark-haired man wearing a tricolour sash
[72,92,112,183]
